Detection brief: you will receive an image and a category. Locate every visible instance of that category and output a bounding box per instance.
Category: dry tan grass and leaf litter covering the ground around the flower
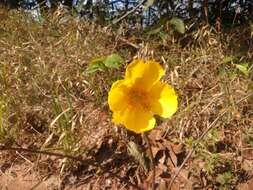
[0,6,253,189]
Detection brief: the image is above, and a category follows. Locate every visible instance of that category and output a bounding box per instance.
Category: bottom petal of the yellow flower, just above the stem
[113,107,156,133]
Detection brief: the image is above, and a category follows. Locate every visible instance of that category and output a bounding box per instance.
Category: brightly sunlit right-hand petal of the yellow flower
[149,81,178,118]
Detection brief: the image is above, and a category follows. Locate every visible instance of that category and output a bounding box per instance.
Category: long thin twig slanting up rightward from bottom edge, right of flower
[168,110,227,189]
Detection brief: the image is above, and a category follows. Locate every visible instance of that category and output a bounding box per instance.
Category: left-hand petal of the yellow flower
[108,80,128,112]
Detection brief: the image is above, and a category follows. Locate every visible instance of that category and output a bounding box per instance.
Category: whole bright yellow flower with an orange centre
[108,60,178,133]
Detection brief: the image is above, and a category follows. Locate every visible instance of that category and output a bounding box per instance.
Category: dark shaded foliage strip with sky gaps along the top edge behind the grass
[3,0,253,27]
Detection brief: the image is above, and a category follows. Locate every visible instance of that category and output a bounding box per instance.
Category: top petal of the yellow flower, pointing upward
[125,60,165,90]
